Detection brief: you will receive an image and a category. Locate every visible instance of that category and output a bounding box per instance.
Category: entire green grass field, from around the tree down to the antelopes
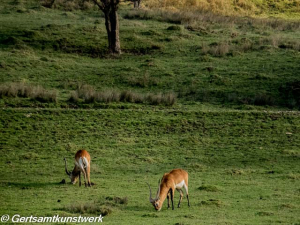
[0,0,300,224]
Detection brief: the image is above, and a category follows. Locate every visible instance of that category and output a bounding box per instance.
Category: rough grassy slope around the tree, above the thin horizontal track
[0,1,300,108]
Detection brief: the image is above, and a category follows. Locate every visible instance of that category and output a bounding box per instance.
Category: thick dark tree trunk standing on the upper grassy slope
[104,7,121,54]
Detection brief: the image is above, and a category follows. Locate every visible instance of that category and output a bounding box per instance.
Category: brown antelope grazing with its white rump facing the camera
[64,150,91,187]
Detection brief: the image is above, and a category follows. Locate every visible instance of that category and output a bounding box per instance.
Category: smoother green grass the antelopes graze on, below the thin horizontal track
[0,109,300,224]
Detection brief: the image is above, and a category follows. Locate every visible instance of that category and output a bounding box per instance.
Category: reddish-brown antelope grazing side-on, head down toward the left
[147,169,190,211]
